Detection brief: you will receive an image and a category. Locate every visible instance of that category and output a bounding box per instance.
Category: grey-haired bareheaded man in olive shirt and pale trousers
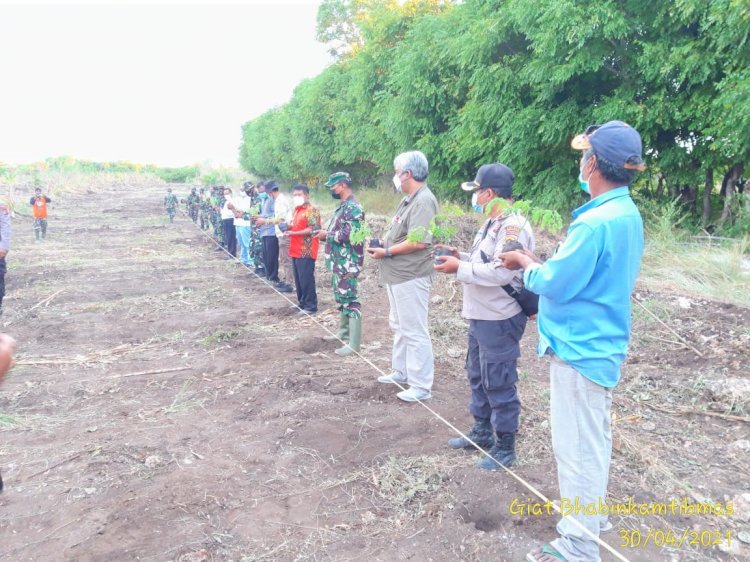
[367,150,438,402]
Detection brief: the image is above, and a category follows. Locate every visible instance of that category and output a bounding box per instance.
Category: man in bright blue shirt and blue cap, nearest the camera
[500,121,645,562]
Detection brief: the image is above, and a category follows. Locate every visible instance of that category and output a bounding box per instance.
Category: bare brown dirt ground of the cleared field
[0,182,750,562]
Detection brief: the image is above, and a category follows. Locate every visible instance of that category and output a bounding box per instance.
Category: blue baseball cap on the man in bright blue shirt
[570,121,646,171]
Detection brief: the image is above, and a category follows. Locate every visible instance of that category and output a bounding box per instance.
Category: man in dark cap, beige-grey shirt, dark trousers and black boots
[435,164,534,470]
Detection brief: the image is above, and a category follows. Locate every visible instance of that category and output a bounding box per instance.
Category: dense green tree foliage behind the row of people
[240,0,750,225]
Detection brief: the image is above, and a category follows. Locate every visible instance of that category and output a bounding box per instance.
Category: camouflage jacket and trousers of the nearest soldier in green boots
[325,195,365,318]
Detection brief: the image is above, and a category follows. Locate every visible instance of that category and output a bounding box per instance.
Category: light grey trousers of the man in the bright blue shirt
[550,355,612,562]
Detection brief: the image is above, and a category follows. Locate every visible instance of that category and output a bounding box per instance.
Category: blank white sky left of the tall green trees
[0,0,331,166]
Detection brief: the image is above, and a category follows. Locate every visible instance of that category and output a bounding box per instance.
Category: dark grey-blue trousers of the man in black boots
[466,312,526,433]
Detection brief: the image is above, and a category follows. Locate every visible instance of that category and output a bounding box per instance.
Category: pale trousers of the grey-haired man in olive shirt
[385,277,435,391]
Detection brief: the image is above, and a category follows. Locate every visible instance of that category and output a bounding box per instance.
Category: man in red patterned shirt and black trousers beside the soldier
[284,185,320,314]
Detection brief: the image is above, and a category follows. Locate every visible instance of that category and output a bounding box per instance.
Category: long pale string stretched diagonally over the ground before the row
[180,210,630,562]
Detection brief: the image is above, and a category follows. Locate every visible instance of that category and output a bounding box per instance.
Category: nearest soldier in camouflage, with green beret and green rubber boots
[318,172,365,355]
